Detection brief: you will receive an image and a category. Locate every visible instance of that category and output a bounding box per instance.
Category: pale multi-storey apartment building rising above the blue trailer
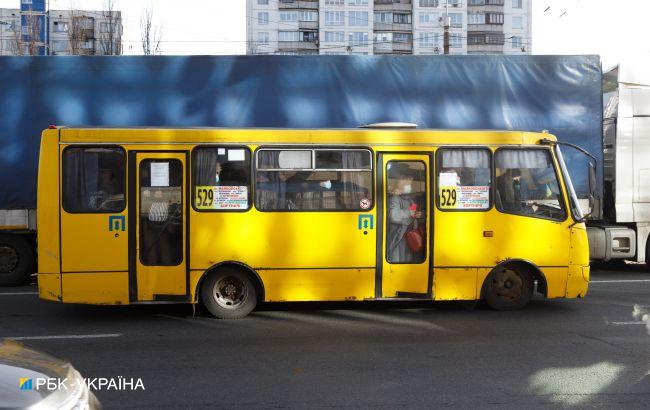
[246,0,532,54]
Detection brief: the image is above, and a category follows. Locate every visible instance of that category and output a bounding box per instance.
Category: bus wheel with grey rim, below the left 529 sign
[201,267,257,319]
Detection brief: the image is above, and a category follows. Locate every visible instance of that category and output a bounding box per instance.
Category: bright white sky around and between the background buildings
[0,0,650,69]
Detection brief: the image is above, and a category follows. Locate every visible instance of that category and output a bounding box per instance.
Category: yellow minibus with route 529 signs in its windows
[37,126,589,318]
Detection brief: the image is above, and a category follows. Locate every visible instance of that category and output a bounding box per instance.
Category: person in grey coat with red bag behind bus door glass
[386,164,423,263]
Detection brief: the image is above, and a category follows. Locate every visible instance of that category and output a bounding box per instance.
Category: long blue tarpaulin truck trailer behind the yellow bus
[0,55,603,285]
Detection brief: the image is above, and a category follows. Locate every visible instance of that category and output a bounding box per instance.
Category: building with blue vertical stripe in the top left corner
[0,0,122,55]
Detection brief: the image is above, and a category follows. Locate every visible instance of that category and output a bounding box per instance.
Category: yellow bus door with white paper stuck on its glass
[129,152,189,302]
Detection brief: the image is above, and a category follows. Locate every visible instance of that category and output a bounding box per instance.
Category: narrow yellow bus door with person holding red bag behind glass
[376,154,432,298]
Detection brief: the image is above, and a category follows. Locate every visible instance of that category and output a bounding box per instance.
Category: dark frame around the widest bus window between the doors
[251,145,377,213]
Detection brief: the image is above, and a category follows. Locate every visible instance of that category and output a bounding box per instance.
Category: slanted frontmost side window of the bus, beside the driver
[495,149,567,221]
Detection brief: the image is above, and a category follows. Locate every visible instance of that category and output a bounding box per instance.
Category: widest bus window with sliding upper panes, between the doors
[255,149,373,211]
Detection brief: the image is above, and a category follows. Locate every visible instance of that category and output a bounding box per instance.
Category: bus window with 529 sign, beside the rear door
[192,146,251,211]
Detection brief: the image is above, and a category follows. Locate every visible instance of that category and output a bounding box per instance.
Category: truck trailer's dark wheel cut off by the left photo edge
[0,235,34,286]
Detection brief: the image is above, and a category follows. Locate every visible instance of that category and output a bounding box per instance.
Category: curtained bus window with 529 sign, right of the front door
[437,148,492,211]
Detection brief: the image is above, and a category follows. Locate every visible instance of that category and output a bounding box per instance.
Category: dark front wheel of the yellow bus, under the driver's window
[483,266,534,310]
